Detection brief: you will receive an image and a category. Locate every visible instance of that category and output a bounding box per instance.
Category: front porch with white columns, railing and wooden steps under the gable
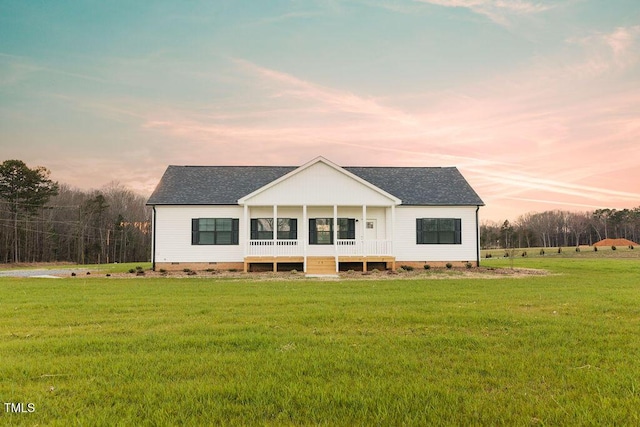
[244,204,395,274]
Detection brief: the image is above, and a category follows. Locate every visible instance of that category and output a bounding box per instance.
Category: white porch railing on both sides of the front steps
[247,239,393,257]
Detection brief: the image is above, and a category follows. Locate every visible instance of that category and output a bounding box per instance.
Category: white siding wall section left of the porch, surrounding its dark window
[155,206,247,262]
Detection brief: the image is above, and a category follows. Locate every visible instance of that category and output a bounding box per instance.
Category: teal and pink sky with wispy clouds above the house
[0,0,640,221]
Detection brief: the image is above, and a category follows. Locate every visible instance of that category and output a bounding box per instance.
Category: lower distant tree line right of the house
[480,206,640,249]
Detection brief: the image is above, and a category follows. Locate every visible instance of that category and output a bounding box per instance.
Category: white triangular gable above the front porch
[238,158,401,206]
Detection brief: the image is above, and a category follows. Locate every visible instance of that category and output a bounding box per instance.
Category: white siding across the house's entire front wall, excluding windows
[155,206,477,262]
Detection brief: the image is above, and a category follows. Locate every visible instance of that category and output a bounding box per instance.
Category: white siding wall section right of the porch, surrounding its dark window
[393,206,478,262]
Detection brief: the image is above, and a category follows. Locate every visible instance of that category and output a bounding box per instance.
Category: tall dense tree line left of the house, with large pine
[0,160,151,264]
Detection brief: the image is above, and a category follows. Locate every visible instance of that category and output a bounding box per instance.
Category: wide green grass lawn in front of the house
[0,256,640,426]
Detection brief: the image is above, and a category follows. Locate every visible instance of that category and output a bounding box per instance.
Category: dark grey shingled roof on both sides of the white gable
[147,166,484,206]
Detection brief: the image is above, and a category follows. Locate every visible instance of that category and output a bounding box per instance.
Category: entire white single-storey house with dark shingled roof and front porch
[147,157,484,274]
